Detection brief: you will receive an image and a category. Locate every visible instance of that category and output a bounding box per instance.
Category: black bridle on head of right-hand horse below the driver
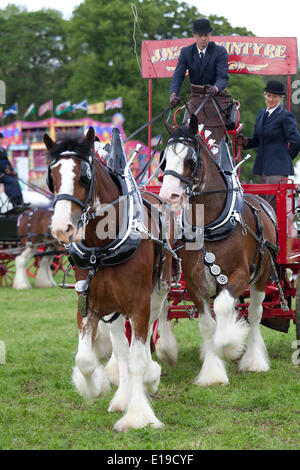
[164,137,202,197]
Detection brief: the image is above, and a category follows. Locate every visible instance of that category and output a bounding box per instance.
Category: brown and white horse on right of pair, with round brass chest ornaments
[160,115,276,386]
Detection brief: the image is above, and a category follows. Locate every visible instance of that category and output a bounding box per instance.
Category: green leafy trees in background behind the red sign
[0,0,300,179]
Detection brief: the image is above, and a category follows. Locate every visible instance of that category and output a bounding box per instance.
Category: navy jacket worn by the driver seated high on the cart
[170,41,228,95]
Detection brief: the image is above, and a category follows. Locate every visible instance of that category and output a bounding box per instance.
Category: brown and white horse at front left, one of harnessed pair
[44,128,172,432]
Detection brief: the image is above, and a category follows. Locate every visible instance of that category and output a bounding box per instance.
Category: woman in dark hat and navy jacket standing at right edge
[237,80,300,210]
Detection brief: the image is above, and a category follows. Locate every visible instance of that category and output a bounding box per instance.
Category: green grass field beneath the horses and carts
[0,272,300,450]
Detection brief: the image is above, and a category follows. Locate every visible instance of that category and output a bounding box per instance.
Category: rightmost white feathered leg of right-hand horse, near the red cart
[239,287,270,372]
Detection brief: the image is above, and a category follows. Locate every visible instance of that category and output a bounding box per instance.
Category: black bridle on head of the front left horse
[47,150,96,227]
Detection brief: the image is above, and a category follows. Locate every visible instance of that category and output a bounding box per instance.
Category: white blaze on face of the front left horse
[51,158,75,236]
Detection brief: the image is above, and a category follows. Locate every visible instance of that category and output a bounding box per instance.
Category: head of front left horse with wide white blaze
[44,127,95,243]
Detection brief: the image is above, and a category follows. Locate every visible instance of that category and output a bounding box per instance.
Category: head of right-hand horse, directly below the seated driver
[159,114,201,206]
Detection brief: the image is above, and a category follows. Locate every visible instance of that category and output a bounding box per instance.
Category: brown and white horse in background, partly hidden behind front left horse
[13,208,64,289]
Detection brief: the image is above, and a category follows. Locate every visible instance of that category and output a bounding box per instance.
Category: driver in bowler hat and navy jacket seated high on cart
[170,18,228,143]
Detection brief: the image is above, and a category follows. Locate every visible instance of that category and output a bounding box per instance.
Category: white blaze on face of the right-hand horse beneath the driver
[159,143,188,202]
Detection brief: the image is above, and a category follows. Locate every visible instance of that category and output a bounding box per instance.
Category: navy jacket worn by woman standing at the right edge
[245,105,300,176]
